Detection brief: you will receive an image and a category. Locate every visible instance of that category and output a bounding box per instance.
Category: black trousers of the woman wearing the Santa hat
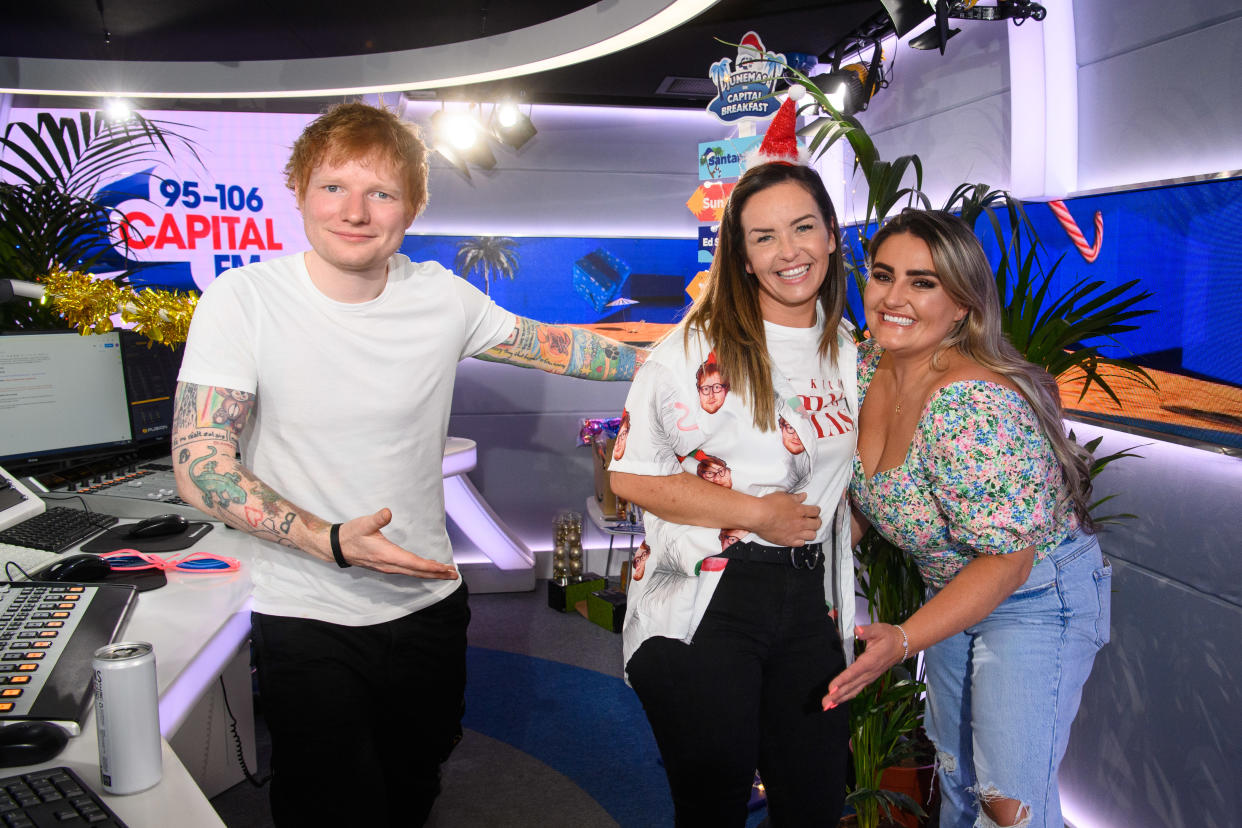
[627,560,850,828]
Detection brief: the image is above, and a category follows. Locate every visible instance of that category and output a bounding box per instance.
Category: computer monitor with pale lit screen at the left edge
[0,331,133,472]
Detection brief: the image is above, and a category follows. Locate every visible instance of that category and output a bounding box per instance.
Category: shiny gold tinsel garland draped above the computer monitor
[42,271,199,345]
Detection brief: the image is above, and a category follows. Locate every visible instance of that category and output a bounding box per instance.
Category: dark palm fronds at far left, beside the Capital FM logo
[0,112,197,329]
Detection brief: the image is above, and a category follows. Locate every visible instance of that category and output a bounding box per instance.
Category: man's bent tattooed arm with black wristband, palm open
[173,382,457,578]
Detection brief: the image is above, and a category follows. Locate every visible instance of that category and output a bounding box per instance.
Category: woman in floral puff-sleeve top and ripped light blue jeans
[823,210,1112,828]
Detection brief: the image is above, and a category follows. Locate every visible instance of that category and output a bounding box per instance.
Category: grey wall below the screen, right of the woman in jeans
[1061,423,1242,828]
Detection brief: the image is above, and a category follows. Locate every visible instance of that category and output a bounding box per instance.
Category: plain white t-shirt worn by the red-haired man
[178,253,517,626]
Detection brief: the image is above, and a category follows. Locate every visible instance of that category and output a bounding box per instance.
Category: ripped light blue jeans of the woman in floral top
[923,534,1113,828]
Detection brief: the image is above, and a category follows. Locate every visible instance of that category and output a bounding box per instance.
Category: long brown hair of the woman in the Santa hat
[682,163,846,431]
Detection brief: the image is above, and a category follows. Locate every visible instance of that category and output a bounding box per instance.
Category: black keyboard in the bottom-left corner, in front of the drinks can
[0,767,125,828]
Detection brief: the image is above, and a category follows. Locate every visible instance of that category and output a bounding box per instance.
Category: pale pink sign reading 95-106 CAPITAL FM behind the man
[10,108,313,290]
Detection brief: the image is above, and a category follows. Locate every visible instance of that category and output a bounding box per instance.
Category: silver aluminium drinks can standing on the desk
[92,642,164,793]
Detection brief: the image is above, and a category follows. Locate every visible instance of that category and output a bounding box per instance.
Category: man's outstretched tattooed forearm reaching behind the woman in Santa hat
[478,317,647,380]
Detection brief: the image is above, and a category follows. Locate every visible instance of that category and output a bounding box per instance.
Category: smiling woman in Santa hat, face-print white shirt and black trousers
[611,87,856,828]
